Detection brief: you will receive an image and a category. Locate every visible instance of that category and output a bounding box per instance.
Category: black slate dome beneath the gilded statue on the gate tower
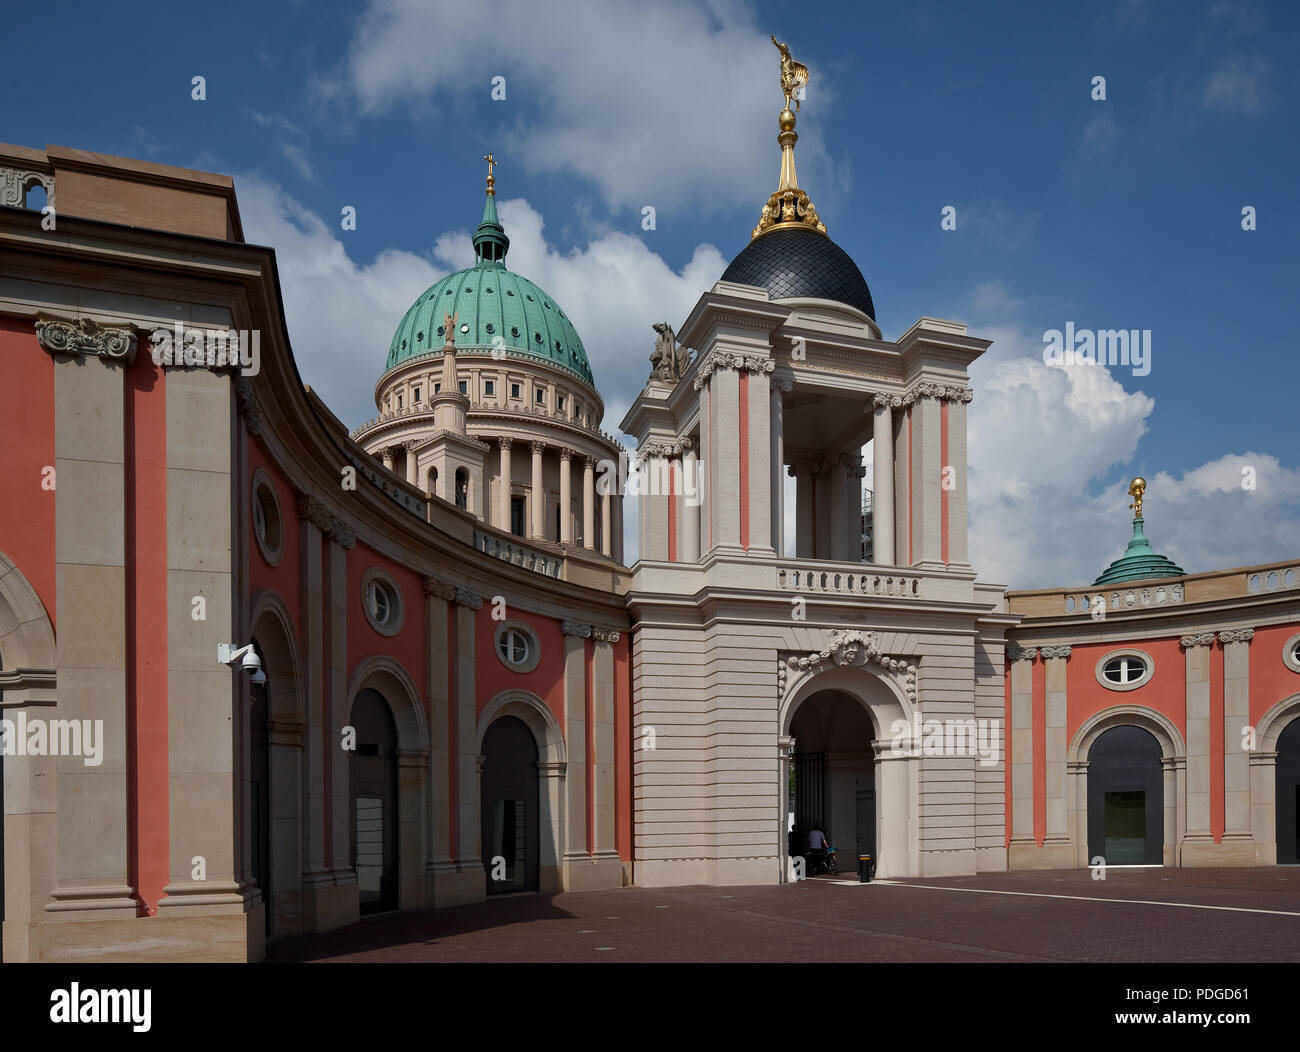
[723,229,876,321]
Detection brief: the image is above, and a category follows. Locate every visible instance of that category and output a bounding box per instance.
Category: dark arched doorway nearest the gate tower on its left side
[478,715,541,895]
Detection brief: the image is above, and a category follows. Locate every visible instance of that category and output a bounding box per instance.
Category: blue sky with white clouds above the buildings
[0,0,1300,586]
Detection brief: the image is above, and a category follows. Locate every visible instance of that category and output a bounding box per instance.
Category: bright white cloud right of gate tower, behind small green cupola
[969,299,1300,588]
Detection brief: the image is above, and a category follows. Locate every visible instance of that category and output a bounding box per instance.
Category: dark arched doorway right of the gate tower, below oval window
[1088,724,1165,866]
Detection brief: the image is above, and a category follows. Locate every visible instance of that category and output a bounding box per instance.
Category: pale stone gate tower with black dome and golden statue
[621,38,1015,886]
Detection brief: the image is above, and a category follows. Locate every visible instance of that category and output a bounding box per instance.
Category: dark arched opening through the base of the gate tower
[787,690,876,874]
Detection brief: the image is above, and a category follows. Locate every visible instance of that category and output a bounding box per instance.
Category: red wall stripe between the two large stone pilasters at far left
[124,355,167,917]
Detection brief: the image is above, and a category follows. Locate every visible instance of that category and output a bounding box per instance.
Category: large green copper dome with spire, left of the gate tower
[386,183,595,388]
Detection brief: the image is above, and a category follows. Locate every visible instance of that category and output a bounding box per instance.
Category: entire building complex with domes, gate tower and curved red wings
[0,79,1300,961]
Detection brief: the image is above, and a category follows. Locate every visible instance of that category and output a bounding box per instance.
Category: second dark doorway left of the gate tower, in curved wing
[350,689,398,914]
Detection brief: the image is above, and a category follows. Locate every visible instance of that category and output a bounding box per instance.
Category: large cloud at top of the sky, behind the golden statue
[317,0,848,211]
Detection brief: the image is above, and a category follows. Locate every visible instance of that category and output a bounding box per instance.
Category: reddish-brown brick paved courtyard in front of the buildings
[268,867,1300,962]
